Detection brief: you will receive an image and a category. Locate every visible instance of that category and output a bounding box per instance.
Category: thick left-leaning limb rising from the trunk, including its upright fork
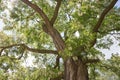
[22,0,65,51]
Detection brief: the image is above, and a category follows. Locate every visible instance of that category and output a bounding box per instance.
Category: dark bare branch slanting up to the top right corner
[93,0,118,32]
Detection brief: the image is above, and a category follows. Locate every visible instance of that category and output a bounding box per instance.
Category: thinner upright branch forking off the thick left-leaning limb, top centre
[50,0,62,25]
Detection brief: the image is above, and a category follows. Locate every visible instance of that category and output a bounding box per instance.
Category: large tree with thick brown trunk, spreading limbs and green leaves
[0,0,120,80]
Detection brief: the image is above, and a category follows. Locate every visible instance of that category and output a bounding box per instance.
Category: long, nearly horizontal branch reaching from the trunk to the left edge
[0,44,58,54]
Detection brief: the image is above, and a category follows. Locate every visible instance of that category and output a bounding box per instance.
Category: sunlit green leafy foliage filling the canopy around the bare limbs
[0,0,120,80]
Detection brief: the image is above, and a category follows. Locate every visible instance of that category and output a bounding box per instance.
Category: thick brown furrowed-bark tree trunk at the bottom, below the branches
[64,58,89,80]
